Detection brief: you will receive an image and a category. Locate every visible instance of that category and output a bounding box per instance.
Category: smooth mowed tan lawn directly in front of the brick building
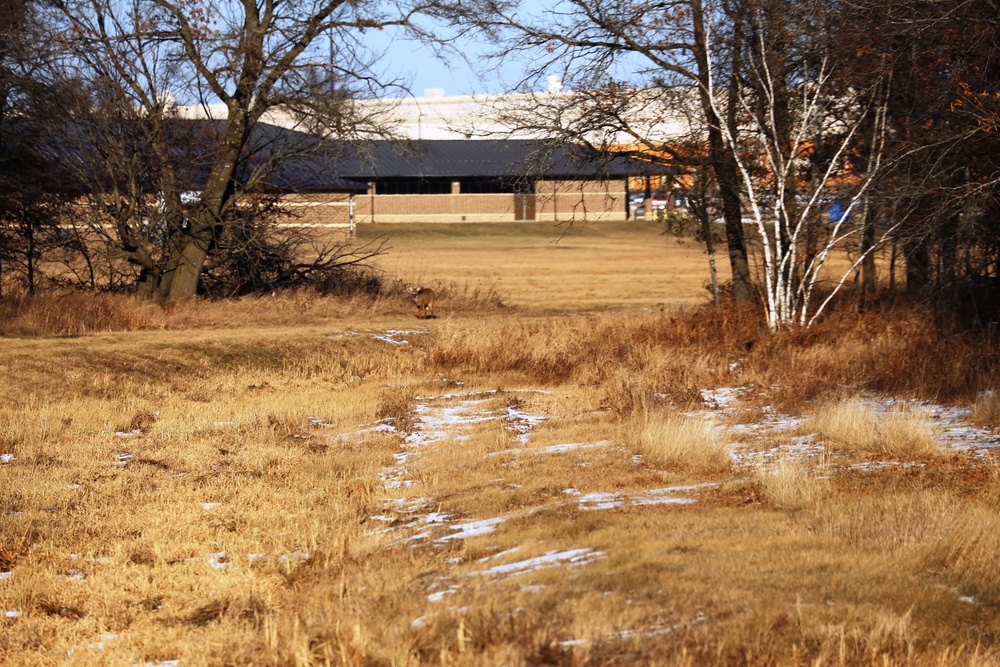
[358,222,730,312]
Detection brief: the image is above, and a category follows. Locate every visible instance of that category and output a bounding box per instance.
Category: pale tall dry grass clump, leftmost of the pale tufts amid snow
[626,410,733,474]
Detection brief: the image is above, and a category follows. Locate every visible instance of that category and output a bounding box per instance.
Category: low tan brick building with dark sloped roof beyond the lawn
[320,140,662,223]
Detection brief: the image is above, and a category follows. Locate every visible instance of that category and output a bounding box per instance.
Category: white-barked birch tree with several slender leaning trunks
[706,0,895,330]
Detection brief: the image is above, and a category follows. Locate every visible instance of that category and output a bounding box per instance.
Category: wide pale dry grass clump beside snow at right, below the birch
[803,399,944,459]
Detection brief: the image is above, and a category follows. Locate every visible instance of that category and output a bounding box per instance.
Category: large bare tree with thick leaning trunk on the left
[47,0,433,298]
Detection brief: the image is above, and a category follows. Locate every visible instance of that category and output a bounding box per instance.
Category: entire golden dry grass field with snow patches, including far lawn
[0,226,1000,667]
